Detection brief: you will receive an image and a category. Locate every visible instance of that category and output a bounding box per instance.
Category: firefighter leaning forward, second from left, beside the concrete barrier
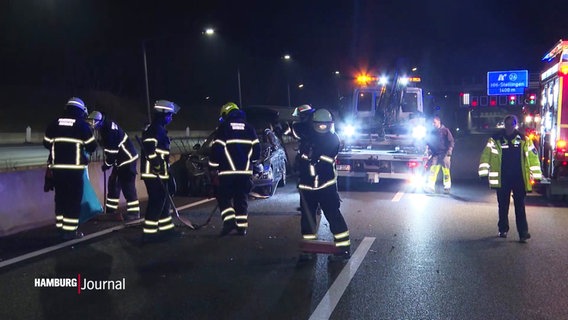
[87,111,140,221]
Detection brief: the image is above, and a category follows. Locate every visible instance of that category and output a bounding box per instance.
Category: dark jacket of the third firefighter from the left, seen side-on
[140,121,170,180]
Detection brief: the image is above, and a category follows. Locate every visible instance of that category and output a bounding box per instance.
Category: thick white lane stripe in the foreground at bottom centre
[310,237,375,320]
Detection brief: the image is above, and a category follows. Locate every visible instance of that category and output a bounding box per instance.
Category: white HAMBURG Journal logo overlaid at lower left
[34,274,126,294]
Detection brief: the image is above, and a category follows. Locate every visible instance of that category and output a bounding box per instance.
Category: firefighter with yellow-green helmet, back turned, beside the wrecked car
[209,102,260,236]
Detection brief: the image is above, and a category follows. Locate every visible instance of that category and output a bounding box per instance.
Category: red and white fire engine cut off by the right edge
[539,40,568,197]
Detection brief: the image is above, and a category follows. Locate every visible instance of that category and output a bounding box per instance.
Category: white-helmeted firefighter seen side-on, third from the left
[140,100,179,242]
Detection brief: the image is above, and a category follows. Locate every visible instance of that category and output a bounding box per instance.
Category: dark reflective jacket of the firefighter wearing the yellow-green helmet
[209,112,260,176]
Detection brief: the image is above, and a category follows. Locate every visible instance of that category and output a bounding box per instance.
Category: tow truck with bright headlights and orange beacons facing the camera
[336,73,427,187]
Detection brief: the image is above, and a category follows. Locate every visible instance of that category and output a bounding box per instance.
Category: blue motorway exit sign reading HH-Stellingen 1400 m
[487,70,529,95]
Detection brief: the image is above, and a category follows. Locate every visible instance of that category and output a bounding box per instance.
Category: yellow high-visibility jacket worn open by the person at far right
[479,131,542,191]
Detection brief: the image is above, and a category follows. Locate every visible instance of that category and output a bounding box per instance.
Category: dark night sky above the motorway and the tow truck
[0,0,568,109]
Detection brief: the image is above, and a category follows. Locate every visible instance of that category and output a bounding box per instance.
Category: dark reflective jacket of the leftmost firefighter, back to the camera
[43,110,97,170]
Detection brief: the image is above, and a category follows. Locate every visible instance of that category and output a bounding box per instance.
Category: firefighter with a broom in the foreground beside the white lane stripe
[298,109,351,260]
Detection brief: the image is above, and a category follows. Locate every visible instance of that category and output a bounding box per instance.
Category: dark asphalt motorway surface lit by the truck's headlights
[0,180,568,319]
